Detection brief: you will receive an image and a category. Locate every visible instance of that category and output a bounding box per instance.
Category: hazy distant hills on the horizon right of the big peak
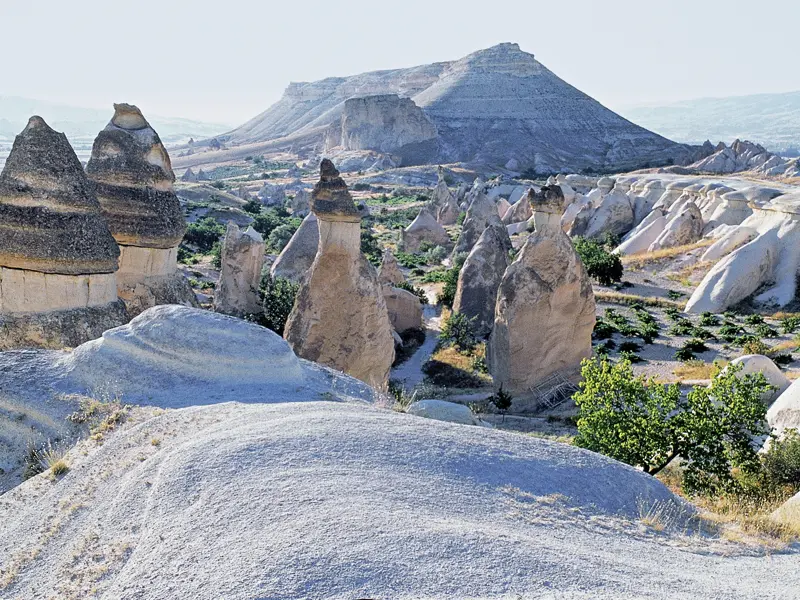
[621,92,800,156]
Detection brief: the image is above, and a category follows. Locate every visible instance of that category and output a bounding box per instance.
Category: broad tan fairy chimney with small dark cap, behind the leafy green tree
[487,186,595,411]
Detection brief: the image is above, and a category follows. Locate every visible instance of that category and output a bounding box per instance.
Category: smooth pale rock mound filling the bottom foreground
[0,402,800,600]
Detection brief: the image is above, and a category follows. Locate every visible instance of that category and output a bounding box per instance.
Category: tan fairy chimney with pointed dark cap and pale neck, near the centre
[284,159,394,387]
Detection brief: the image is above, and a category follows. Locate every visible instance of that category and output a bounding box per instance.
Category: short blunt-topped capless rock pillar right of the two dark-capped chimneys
[214,223,264,317]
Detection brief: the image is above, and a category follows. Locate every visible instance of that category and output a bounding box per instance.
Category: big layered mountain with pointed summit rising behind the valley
[179,43,702,173]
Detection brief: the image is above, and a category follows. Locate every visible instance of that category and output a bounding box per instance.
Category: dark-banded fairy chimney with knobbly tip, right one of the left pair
[86,104,196,314]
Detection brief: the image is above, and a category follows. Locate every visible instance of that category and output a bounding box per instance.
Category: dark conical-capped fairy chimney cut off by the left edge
[0,117,127,350]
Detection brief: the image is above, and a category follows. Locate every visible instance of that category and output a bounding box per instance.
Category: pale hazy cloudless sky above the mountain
[0,0,800,124]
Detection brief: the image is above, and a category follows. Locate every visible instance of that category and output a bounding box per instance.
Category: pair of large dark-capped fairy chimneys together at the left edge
[0,104,195,349]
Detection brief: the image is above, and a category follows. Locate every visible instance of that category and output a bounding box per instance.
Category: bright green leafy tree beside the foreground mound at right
[574,359,770,492]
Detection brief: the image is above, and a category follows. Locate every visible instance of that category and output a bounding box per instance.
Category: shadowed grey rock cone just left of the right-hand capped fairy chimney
[453,225,511,337]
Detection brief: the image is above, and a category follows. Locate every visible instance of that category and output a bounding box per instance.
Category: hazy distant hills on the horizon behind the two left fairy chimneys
[0,96,230,164]
